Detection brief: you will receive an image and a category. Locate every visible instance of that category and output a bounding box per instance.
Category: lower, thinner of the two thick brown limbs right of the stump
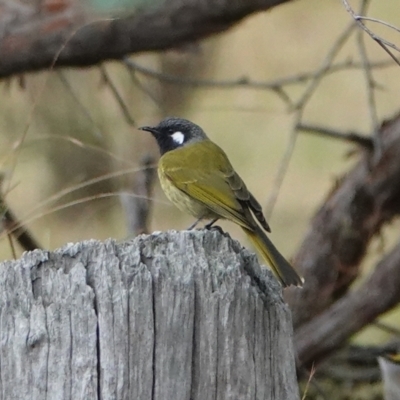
[295,239,400,365]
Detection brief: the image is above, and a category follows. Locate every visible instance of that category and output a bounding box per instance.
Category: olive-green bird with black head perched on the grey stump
[139,117,304,287]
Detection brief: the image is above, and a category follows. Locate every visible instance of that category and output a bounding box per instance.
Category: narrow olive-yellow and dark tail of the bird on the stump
[243,226,304,287]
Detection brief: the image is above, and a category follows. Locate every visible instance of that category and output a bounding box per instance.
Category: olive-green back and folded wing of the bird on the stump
[160,141,258,231]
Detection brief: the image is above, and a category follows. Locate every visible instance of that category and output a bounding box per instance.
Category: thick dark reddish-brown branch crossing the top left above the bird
[0,0,290,78]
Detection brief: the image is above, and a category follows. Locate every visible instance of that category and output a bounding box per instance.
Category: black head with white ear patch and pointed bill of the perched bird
[139,117,207,155]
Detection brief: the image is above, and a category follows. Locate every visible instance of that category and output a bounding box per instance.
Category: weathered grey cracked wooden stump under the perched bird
[0,231,299,400]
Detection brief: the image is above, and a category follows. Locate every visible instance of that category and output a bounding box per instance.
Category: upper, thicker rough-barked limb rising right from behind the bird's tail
[286,111,400,328]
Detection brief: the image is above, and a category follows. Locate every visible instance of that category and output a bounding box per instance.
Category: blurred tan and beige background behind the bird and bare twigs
[0,0,400,398]
